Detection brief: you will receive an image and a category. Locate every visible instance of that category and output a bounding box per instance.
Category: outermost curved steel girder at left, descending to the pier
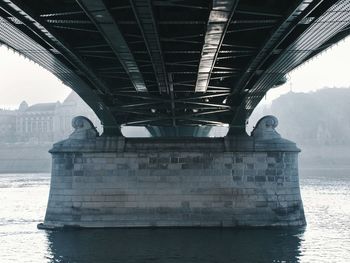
[0,4,122,136]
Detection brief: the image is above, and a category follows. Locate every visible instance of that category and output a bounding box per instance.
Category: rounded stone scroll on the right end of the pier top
[251,115,281,140]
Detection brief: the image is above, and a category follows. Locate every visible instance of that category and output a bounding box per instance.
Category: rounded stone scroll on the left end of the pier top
[69,116,99,140]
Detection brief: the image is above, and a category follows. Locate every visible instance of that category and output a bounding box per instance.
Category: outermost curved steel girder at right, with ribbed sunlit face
[231,0,350,130]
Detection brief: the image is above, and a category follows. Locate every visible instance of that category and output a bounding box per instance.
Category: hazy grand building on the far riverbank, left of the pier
[0,92,100,143]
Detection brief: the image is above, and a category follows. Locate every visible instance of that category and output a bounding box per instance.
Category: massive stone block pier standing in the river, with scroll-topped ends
[41,116,305,228]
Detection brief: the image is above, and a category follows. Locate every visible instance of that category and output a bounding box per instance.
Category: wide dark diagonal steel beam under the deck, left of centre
[76,0,147,92]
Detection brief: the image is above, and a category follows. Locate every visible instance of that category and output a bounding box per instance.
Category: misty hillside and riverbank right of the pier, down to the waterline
[249,88,350,168]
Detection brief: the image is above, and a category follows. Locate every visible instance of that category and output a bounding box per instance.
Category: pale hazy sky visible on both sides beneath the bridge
[0,35,350,108]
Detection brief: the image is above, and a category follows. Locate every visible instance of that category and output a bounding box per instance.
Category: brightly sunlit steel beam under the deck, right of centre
[195,0,238,92]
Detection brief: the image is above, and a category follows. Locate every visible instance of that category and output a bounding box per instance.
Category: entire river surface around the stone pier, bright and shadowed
[0,169,350,263]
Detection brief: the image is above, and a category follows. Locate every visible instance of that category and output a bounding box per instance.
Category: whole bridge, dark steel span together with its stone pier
[0,0,350,228]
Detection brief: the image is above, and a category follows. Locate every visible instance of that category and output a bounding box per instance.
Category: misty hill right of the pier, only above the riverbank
[250,88,350,145]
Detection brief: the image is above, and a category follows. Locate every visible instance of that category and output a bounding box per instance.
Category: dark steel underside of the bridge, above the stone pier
[0,0,350,136]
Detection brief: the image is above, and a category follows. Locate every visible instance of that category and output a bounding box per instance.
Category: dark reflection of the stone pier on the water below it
[47,229,303,263]
